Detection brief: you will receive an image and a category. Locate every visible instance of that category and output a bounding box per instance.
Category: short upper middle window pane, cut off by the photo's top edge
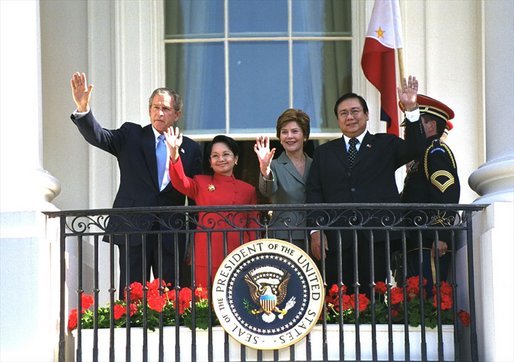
[228,0,288,37]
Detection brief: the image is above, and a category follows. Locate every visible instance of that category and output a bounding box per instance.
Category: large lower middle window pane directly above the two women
[229,42,289,133]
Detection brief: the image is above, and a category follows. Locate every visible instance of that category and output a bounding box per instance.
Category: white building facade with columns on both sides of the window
[0,0,514,361]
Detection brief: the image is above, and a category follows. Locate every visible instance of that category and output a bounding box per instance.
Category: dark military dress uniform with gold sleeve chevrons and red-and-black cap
[401,95,460,295]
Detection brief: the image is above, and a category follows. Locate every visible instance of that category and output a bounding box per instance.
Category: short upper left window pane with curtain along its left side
[164,0,224,39]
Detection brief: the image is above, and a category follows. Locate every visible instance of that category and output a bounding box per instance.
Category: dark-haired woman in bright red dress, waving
[166,127,258,287]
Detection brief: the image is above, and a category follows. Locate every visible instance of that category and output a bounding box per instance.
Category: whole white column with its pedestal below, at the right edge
[468,0,514,361]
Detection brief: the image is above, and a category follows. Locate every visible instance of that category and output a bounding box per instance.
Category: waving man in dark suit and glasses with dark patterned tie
[307,77,424,295]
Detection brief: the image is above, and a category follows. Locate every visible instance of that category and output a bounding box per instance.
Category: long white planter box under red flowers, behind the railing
[72,324,454,361]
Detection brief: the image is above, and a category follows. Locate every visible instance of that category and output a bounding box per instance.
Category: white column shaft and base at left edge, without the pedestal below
[0,0,60,211]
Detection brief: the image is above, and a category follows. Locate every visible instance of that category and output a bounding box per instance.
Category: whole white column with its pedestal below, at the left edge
[0,0,60,361]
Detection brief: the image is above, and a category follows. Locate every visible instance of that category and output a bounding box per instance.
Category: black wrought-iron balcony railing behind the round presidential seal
[46,204,484,361]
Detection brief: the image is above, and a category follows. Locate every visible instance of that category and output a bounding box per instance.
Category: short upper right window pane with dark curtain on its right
[292,0,352,36]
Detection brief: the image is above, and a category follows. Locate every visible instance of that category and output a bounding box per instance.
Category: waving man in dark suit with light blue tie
[71,73,202,297]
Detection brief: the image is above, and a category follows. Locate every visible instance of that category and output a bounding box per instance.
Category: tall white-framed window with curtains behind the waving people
[164,0,352,139]
